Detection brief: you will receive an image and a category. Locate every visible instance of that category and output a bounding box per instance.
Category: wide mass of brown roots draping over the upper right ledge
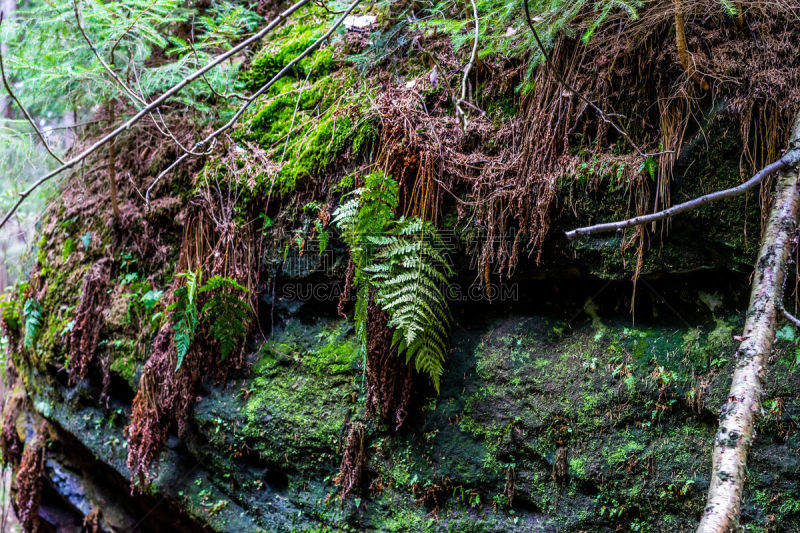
[376,0,800,281]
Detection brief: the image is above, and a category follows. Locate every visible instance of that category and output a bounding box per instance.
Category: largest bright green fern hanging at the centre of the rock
[333,172,452,391]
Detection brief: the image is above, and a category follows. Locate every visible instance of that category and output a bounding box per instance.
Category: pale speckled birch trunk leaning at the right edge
[697,110,800,533]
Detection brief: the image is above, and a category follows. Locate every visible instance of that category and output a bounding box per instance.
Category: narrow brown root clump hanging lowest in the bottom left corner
[15,422,46,532]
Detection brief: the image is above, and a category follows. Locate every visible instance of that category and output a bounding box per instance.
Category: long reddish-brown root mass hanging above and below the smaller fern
[127,183,255,490]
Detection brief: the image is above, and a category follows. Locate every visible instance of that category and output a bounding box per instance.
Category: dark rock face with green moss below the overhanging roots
[4,109,800,532]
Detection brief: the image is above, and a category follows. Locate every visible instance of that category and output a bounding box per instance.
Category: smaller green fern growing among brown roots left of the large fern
[168,271,251,371]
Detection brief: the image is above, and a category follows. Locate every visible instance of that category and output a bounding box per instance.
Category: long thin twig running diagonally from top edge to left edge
[0,0,310,228]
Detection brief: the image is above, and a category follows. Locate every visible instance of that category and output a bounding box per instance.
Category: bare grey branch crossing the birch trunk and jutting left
[566,146,800,239]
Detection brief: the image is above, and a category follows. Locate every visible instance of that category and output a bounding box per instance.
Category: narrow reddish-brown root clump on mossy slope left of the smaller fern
[69,257,112,383]
